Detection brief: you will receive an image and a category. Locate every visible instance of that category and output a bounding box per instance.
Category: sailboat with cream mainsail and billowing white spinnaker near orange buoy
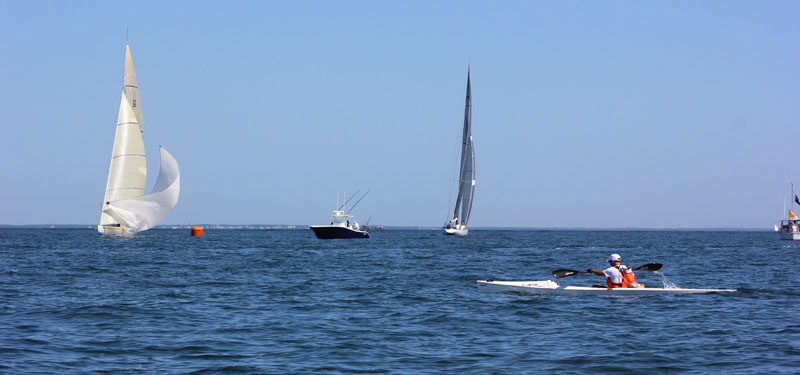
[97,42,181,236]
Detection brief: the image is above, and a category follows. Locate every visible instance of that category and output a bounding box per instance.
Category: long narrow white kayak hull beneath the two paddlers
[478,280,736,296]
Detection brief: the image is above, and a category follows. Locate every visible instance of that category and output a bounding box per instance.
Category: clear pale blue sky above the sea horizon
[0,0,800,229]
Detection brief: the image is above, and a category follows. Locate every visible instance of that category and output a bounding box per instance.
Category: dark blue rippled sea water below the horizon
[0,229,800,374]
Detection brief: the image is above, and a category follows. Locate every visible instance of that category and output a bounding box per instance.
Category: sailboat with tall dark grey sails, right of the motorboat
[444,67,475,236]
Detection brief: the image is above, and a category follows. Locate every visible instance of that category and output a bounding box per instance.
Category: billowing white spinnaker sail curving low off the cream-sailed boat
[103,147,181,233]
